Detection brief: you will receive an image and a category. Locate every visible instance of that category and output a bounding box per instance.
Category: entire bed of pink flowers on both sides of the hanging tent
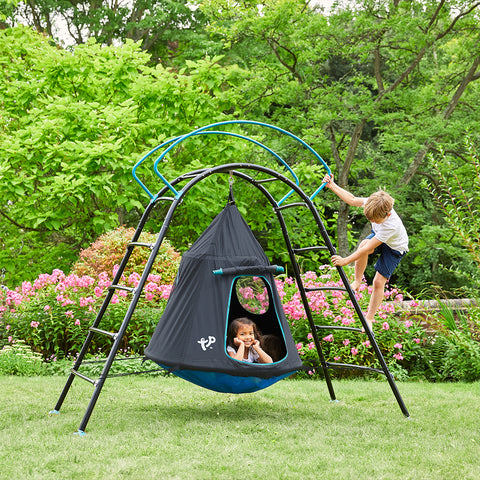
[0,266,428,377]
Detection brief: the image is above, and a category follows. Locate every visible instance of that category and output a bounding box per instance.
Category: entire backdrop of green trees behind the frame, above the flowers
[0,0,480,297]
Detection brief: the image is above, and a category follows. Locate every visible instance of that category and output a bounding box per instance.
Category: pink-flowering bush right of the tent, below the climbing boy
[277,265,427,376]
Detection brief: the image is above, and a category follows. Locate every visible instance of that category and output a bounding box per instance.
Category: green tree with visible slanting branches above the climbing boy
[205,0,480,246]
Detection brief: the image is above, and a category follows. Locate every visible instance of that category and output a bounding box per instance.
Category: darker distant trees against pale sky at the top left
[0,0,220,65]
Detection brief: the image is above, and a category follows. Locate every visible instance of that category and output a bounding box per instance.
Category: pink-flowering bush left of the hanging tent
[0,270,171,359]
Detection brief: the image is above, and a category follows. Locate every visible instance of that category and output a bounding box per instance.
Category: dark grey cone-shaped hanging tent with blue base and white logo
[145,201,303,393]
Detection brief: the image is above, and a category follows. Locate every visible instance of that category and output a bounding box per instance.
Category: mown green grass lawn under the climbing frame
[0,376,480,480]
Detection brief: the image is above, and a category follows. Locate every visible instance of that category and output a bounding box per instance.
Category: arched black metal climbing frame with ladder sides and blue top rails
[50,121,410,435]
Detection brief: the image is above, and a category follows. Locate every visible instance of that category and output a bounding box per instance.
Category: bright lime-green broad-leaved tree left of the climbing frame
[0,28,240,285]
